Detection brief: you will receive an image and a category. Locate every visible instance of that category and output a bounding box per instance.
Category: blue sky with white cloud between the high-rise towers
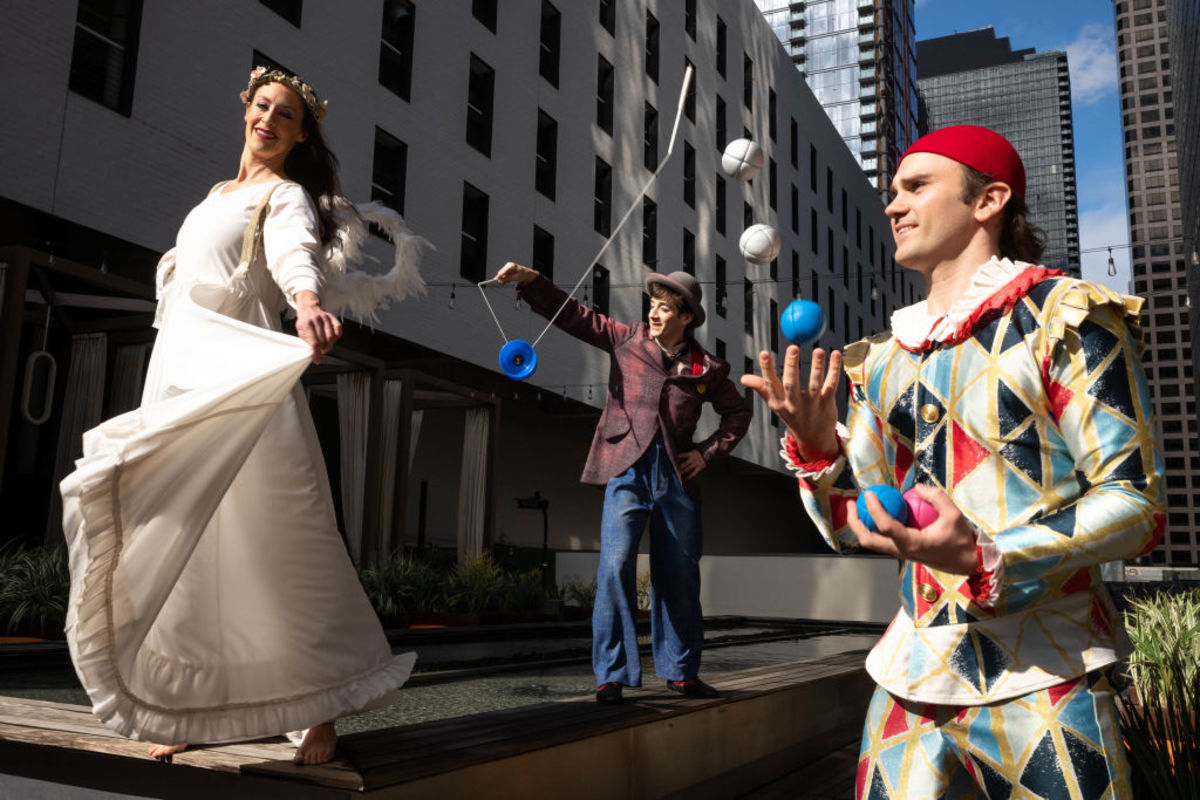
[917,0,1129,291]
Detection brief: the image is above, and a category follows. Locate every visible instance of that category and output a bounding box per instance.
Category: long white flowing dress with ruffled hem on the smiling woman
[61,184,415,742]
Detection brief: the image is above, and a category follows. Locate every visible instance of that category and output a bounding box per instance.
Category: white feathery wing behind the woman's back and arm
[320,199,433,323]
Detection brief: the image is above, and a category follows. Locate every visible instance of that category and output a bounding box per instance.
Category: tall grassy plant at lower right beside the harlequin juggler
[1120,590,1200,800]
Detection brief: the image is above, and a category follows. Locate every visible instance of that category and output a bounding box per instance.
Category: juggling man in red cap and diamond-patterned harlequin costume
[743,126,1164,800]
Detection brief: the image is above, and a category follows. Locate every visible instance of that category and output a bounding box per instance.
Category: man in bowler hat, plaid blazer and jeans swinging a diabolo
[496,263,750,703]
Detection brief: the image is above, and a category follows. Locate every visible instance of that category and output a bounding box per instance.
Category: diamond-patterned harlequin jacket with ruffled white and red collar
[785,259,1165,705]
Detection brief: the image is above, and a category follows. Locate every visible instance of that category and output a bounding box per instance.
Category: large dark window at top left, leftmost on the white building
[70,0,142,116]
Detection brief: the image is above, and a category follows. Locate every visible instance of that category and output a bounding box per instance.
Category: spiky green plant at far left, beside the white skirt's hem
[0,547,71,638]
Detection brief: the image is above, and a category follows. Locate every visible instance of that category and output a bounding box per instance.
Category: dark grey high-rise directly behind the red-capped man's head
[917,28,1079,277]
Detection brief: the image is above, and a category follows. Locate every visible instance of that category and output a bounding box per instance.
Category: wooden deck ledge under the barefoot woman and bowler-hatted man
[0,652,872,800]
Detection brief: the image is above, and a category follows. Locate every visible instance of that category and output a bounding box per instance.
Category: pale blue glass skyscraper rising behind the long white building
[755,0,917,193]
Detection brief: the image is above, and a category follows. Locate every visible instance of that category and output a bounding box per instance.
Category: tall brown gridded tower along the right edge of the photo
[1114,0,1200,565]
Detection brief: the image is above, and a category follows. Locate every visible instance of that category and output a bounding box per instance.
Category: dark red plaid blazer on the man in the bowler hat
[517,276,750,495]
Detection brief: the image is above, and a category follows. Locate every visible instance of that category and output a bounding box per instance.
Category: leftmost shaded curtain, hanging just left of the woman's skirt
[46,333,108,547]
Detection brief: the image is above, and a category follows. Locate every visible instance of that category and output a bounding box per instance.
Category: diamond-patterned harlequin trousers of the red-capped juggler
[856,670,1133,800]
